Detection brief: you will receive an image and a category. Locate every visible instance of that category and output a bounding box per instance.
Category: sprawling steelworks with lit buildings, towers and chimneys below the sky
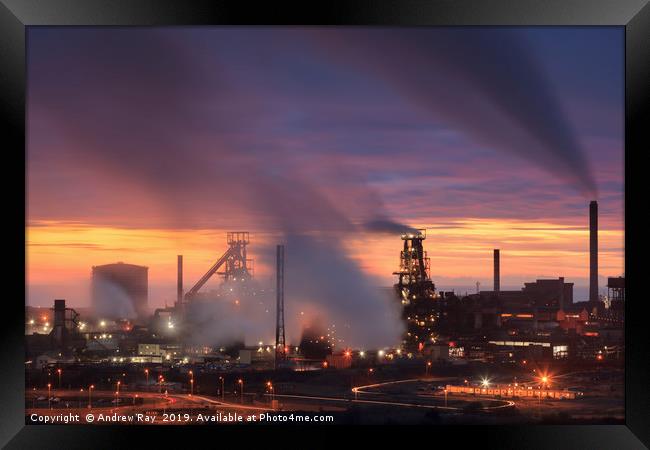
[25,201,626,426]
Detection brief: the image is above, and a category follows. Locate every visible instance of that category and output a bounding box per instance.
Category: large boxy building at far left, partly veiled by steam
[92,262,149,321]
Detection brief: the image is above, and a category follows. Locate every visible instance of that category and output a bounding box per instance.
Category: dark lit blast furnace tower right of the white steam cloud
[394,230,439,352]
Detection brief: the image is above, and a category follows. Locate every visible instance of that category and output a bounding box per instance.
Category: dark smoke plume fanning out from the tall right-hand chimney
[310,28,596,198]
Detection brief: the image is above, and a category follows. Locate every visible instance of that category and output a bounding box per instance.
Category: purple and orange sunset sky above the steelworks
[26,27,624,306]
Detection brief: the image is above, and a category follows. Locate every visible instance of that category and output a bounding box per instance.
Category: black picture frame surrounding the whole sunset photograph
[0,0,650,449]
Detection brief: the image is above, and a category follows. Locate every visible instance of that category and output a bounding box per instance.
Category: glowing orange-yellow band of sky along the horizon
[26,214,624,307]
